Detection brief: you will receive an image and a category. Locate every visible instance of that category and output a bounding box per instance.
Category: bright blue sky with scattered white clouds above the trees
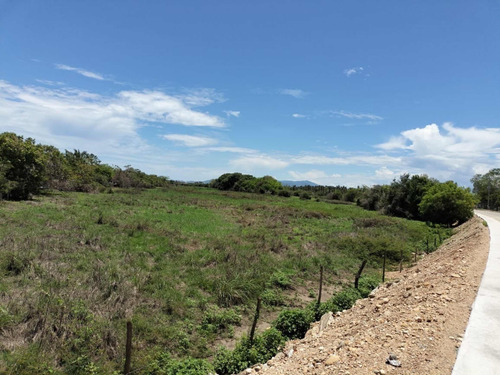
[0,0,500,186]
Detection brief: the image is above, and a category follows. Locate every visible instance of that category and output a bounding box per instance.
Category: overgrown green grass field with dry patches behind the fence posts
[0,186,449,374]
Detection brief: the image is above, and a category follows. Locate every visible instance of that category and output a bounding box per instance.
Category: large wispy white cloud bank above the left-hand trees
[0,81,224,160]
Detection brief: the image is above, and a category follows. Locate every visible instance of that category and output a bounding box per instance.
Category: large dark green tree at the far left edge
[0,133,45,200]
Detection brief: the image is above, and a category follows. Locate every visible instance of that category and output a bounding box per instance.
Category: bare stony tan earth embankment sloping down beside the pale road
[244,217,489,375]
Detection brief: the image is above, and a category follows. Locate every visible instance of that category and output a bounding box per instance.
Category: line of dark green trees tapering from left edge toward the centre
[0,133,169,200]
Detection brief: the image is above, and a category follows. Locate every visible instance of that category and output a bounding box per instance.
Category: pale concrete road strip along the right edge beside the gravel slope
[452,210,500,375]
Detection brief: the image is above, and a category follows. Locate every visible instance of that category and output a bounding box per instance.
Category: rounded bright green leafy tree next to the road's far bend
[419,181,476,225]
